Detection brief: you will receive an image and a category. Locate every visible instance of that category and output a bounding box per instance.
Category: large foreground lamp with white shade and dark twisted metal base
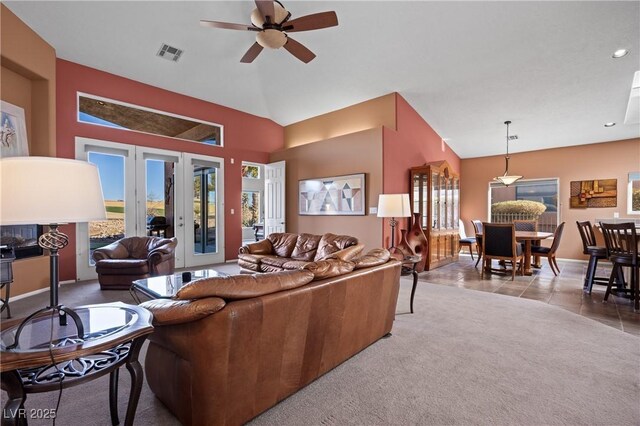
[0,157,107,349]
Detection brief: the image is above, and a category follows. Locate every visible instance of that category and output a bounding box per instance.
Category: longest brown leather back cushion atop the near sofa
[176,271,313,300]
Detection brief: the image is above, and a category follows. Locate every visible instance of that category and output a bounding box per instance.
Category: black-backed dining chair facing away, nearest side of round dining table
[481,222,524,281]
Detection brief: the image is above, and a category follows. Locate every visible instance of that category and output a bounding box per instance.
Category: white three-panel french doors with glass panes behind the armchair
[76,138,224,280]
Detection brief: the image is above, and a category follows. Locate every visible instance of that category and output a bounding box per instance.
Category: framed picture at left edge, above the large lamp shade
[0,101,29,158]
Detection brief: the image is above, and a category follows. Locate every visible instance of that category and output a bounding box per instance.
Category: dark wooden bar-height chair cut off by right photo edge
[600,222,640,311]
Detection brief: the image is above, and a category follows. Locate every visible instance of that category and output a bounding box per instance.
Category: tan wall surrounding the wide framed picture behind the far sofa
[270,127,382,249]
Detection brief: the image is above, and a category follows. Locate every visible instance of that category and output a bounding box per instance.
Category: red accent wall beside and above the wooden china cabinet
[382,93,464,245]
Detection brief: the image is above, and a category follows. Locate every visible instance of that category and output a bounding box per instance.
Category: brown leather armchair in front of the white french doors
[91,237,178,290]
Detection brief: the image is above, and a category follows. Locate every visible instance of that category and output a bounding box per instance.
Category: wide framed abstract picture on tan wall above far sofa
[298,173,365,216]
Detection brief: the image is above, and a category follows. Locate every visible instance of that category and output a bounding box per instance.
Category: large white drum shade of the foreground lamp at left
[0,157,107,225]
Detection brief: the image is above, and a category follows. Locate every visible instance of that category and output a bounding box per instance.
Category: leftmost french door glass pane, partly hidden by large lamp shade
[87,152,125,262]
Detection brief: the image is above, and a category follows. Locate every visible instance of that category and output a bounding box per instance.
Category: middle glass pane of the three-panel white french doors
[145,160,175,238]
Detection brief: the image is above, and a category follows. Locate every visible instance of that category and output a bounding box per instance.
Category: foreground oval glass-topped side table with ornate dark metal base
[0,302,153,426]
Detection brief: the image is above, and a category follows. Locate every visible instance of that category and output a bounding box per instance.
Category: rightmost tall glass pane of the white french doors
[193,165,218,254]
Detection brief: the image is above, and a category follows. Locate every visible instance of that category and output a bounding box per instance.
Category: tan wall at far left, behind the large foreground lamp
[0,5,56,296]
